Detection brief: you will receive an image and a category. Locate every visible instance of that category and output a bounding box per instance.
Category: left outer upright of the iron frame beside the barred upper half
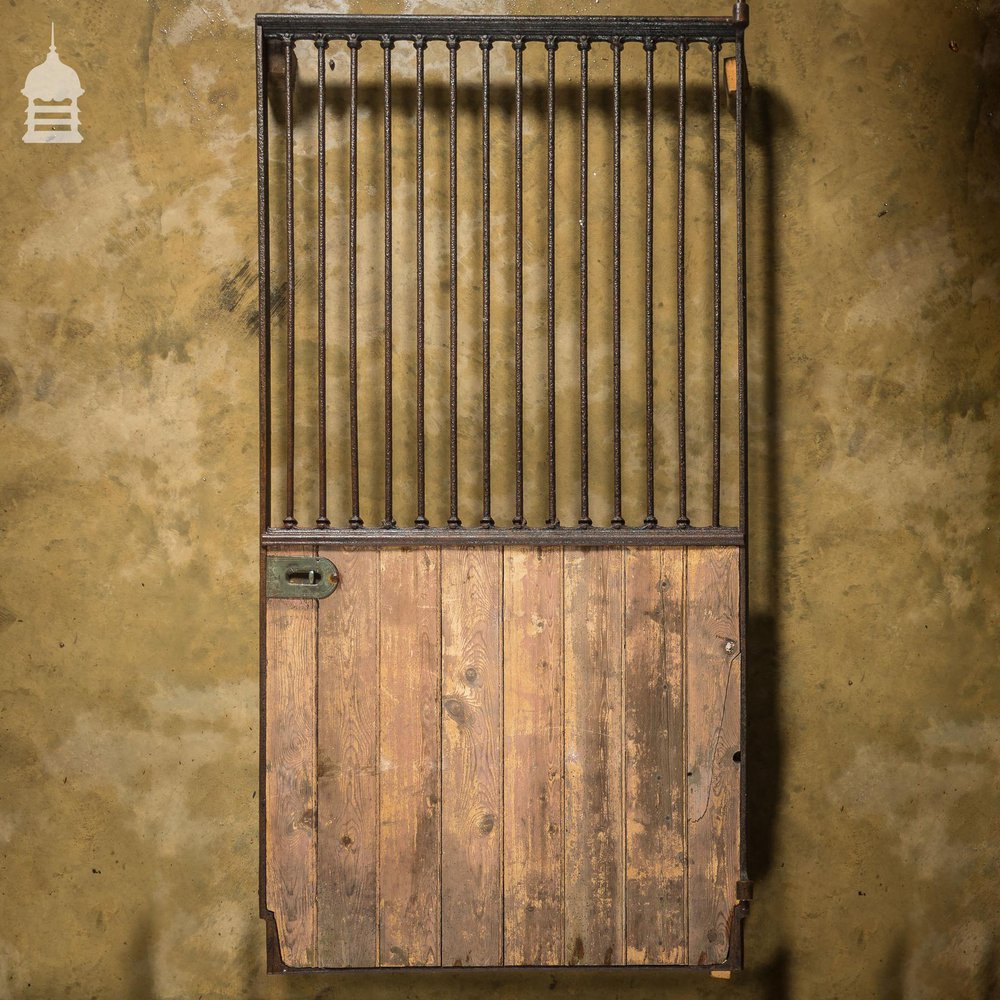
[257,27,271,534]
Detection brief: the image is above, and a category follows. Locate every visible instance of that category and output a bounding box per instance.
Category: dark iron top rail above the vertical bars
[257,3,750,42]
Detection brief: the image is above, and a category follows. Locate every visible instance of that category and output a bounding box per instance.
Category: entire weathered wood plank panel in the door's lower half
[265,547,742,968]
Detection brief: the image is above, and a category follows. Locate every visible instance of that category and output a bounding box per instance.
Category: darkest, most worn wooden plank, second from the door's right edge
[625,548,687,965]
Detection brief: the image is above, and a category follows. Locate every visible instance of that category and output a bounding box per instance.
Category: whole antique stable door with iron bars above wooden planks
[257,4,750,976]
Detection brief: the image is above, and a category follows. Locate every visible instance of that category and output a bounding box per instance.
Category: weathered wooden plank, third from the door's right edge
[563,548,625,965]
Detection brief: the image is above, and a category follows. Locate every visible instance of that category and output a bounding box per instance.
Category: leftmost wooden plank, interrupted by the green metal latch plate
[264,549,316,968]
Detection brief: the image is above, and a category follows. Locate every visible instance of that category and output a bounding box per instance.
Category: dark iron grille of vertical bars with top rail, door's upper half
[257,3,749,535]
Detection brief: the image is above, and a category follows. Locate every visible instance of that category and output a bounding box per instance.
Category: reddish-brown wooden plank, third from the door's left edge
[379,548,441,966]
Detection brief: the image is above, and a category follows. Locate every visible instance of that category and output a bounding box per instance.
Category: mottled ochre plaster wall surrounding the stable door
[0,0,1000,1000]
